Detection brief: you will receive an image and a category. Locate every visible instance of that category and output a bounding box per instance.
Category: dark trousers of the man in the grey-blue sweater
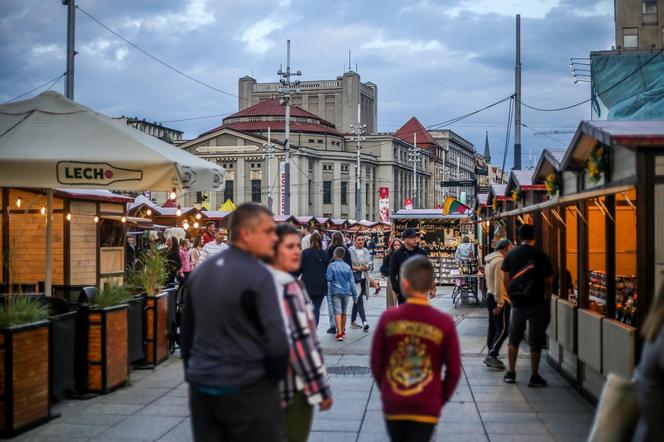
[189,379,284,442]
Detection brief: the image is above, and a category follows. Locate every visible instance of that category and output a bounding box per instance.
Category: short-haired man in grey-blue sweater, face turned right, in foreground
[181,203,290,442]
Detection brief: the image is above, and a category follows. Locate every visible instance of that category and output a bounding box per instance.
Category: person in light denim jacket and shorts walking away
[325,247,357,341]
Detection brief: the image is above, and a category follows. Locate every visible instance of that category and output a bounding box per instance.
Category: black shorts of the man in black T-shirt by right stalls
[509,302,551,353]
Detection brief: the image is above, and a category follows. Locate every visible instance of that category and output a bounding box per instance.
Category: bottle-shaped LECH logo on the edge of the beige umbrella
[57,161,143,186]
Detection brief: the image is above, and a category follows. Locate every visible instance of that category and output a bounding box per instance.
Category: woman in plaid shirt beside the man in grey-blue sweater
[271,224,332,442]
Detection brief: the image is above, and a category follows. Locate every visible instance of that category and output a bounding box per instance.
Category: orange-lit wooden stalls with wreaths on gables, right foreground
[482,121,664,398]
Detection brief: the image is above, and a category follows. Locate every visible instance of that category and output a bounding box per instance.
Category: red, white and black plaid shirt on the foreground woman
[280,281,332,406]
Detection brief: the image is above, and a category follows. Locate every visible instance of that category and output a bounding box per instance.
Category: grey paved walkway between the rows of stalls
[17,289,593,442]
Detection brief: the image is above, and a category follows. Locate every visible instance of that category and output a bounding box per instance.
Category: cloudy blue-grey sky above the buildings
[0,0,614,169]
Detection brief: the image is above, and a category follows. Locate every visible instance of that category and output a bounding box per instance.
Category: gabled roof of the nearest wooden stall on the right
[560,120,664,170]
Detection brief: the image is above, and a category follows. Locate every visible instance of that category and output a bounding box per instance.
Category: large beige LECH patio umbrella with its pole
[0,91,224,293]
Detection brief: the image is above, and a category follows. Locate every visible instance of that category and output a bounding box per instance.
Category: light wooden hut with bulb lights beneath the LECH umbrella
[0,188,132,291]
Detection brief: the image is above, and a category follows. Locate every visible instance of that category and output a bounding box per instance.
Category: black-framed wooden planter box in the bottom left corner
[0,321,51,437]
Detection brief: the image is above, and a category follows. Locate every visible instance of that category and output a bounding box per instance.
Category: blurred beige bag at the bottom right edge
[588,373,639,442]
